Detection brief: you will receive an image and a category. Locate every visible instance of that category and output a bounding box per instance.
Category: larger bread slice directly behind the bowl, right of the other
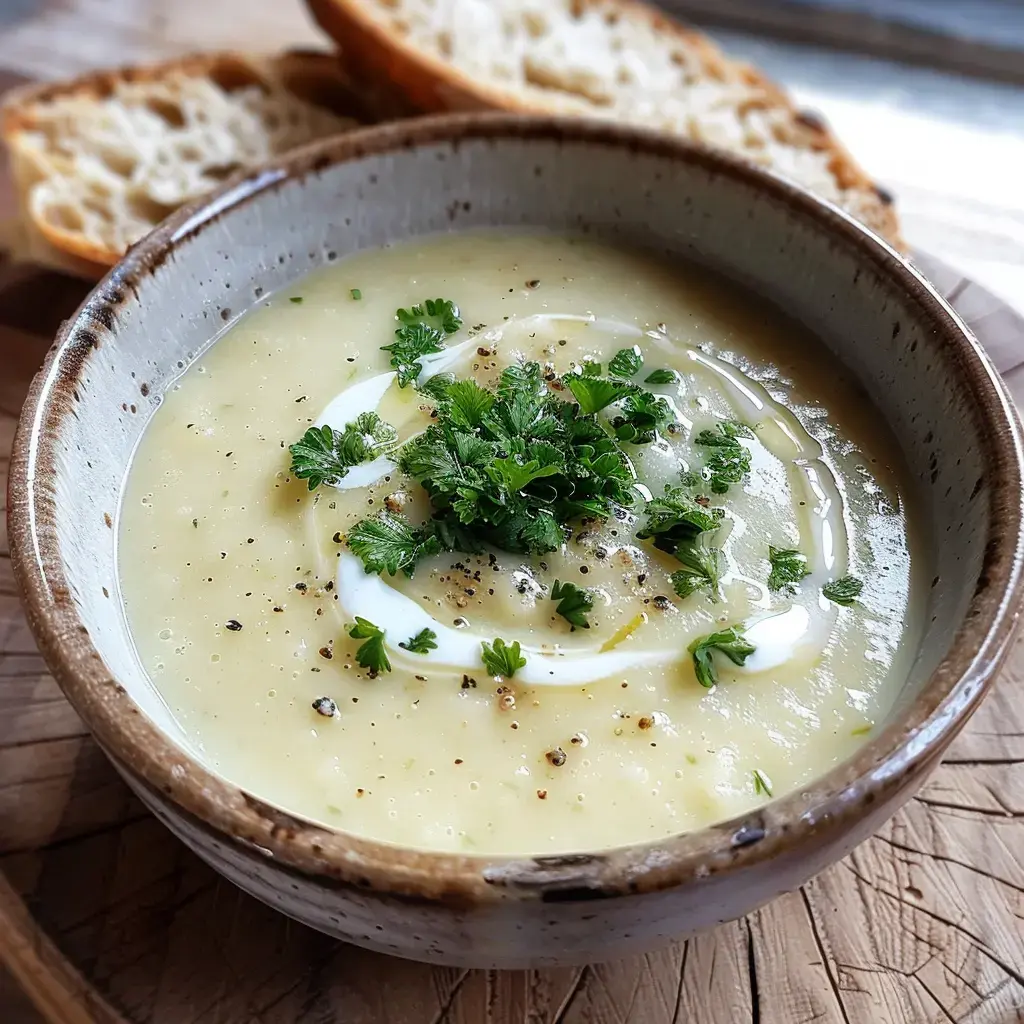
[306,0,902,247]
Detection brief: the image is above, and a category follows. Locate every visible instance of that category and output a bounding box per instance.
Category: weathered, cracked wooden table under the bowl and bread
[0,0,1024,1024]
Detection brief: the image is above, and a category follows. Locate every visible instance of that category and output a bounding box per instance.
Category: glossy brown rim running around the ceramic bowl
[8,114,1024,903]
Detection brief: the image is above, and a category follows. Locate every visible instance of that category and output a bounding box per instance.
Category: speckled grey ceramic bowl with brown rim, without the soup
[9,116,1021,967]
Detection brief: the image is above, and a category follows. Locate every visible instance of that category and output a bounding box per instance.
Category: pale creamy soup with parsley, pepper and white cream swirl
[119,231,925,854]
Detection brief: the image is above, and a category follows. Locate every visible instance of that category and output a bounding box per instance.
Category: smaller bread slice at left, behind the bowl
[0,51,361,276]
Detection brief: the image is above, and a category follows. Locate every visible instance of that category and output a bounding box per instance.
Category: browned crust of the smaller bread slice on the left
[0,50,369,278]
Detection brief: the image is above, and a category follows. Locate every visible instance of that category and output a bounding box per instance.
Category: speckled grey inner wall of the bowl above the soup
[18,123,1019,831]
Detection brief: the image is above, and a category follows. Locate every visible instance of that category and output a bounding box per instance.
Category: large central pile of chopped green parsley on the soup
[349,362,635,571]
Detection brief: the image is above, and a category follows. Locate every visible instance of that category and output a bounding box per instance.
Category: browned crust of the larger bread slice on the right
[306,0,906,250]
